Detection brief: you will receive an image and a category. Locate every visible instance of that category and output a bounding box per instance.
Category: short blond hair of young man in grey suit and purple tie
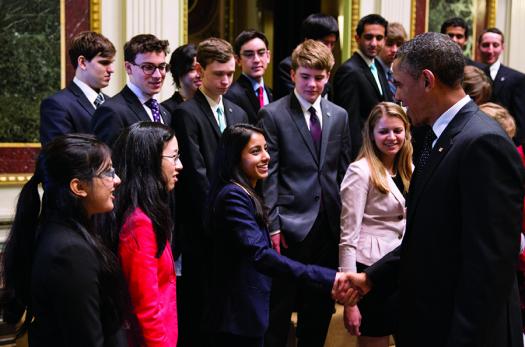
[292,40,334,72]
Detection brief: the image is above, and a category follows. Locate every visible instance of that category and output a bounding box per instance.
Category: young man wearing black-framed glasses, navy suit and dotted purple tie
[91,34,171,146]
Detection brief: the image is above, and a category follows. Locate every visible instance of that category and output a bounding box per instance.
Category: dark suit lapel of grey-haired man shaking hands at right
[408,101,476,220]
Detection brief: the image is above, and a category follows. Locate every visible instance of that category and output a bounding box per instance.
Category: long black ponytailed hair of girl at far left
[2,134,122,334]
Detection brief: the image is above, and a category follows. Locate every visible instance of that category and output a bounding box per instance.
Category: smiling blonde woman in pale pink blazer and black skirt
[339,102,413,347]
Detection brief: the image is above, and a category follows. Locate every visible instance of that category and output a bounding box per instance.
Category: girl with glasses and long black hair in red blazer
[114,122,182,347]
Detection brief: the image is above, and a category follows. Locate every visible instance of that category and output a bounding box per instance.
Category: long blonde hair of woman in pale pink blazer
[357,101,412,194]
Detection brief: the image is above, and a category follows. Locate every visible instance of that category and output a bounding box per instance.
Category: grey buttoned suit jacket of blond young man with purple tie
[259,93,350,242]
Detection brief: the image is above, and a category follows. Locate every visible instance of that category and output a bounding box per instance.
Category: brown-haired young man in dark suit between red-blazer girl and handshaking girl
[172,38,248,346]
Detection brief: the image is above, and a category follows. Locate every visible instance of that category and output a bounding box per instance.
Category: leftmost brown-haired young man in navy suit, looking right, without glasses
[40,31,115,146]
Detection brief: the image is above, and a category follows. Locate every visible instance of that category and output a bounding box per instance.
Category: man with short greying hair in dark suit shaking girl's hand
[349,33,524,347]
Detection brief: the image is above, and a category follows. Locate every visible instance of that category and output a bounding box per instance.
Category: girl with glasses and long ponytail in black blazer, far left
[2,135,125,347]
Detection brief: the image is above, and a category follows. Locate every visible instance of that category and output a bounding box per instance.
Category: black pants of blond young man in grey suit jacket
[264,213,338,347]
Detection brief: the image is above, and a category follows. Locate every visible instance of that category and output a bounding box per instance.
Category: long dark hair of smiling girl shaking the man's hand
[209,124,268,225]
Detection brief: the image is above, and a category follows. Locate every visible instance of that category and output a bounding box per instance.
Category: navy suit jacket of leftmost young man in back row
[40,81,105,146]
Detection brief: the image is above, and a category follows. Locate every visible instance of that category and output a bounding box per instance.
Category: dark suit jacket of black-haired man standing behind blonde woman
[333,52,393,158]
